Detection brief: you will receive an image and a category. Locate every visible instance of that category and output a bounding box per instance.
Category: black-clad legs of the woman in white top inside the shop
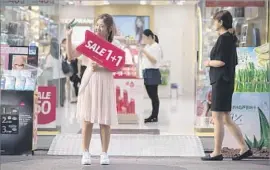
[145,85,159,118]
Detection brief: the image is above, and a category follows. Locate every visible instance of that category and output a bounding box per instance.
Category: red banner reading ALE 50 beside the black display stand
[37,86,56,125]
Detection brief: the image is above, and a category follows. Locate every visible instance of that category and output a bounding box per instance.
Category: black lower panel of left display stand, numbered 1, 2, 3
[0,90,34,155]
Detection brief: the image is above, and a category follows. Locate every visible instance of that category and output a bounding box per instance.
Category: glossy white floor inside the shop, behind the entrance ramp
[57,96,195,135]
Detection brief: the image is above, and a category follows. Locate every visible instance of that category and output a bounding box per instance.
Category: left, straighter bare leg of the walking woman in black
[211,111,224,157]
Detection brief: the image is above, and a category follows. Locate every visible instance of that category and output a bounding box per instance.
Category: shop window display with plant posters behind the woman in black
[195,0,270,157]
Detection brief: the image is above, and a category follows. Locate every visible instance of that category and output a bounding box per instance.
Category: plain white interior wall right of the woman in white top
[154,4,197,97]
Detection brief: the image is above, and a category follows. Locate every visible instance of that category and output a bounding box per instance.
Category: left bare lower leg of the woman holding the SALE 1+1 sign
[82,121,93,152]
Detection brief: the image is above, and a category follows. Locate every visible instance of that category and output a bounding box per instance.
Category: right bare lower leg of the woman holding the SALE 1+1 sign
[100,125,111,153]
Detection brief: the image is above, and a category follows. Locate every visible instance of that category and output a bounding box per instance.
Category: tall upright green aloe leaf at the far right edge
[258,107,270,147]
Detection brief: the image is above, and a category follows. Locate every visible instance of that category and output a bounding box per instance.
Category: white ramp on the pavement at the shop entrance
[48,134,204,157]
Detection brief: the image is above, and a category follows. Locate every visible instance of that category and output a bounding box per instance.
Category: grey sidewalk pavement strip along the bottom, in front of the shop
[0,155,270,170]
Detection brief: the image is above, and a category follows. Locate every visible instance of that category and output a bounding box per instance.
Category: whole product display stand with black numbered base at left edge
[0,45,38,155]
